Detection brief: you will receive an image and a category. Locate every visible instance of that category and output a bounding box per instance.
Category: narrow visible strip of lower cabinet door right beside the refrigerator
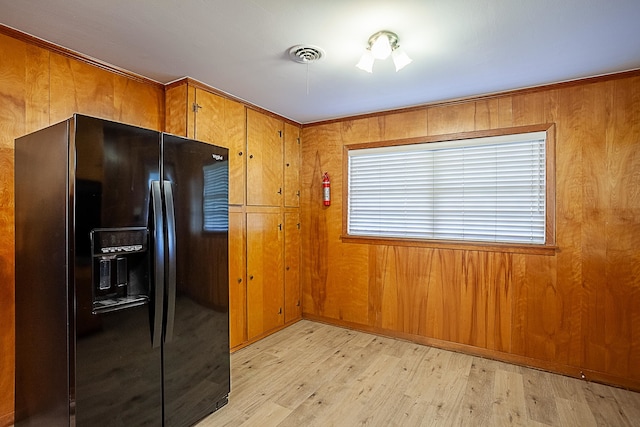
[229,212,247,348]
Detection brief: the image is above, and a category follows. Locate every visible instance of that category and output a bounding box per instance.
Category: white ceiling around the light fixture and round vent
[0,0,640,123]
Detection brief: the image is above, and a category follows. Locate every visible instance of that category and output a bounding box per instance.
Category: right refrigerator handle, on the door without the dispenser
[163,181,177,342]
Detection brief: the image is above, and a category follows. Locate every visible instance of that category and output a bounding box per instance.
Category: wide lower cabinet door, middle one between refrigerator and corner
[247,212,284,339]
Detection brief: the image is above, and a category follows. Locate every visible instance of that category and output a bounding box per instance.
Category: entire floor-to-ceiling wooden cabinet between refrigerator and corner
[165,78,302,350]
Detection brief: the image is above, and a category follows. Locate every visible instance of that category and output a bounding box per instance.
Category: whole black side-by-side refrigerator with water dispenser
[15,115,230,426]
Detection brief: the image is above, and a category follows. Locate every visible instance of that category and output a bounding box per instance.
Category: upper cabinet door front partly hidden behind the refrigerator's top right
[195,88,246,205]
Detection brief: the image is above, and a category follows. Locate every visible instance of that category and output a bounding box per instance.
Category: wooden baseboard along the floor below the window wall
[302,313,640,392]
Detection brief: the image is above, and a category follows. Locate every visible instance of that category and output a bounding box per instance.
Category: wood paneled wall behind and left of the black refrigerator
[0,26,164,426]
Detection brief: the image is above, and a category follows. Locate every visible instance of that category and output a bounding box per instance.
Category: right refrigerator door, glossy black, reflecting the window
[162,135,230,426]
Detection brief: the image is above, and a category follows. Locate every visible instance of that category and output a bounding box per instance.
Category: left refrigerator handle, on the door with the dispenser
[151,181,164,348]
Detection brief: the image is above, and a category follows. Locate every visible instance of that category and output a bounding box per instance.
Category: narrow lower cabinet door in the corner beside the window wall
[284,212,302,323]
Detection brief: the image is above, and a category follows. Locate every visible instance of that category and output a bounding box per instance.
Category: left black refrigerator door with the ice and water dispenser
[70,116,163,426]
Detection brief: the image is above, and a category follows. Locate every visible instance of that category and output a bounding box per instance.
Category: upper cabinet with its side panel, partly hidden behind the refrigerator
[165,82,246,205]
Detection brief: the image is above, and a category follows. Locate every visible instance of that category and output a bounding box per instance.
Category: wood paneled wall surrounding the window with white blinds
[301,72,640,390]
